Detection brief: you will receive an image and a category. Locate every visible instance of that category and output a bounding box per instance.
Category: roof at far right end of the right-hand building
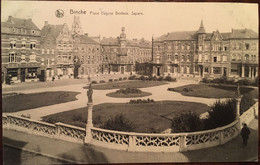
[230,29,258,38]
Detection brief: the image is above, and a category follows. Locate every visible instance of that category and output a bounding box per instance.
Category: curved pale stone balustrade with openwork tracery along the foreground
[2,102,258,152]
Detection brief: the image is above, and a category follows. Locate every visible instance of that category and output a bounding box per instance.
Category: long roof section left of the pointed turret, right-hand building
[155,31,196,41]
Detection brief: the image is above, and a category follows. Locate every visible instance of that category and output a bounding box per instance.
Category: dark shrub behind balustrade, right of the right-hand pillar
[240,91,255,115]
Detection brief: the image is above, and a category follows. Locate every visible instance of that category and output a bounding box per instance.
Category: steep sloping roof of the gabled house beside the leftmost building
[41,24,63,39]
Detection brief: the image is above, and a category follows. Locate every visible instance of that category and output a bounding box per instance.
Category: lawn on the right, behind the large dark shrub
[171,84,257,98]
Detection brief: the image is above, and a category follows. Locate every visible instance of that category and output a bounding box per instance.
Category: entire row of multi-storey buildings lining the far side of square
[1,16,258,82]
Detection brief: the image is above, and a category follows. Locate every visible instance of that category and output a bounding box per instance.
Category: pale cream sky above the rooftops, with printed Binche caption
[1,1,258,40]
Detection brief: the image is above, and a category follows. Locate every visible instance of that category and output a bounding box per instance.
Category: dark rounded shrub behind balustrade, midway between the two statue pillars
[171,112,202,133]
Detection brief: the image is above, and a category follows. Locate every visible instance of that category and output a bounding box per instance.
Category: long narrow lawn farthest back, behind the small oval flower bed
[84,80,167,90]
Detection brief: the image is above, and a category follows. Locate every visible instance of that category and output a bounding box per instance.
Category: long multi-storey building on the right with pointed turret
[152,21,258,78]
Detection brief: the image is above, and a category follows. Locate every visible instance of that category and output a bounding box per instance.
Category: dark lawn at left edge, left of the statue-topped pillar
[2,91,79,112]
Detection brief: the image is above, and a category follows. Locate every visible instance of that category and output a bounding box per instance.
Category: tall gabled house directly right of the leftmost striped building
[41,21,74,80]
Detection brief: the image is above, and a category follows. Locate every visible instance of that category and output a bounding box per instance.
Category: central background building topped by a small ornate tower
[100,27,151,74]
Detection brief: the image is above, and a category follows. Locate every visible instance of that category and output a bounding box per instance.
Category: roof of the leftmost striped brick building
[1,16,39,30]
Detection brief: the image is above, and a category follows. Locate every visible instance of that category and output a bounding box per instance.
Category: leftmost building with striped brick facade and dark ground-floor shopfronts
[1,16,40,82]
